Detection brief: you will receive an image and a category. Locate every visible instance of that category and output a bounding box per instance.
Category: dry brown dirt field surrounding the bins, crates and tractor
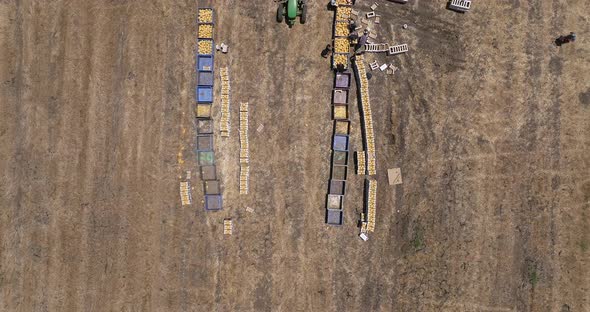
[0,0,590,312]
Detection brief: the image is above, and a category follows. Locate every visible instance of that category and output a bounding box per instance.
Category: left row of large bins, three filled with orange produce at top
[195,8,223,210]
